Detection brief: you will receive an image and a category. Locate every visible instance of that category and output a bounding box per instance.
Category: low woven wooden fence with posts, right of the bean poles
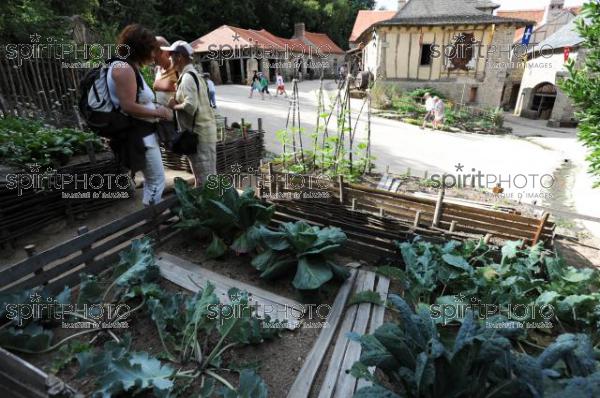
[257,166,556,252]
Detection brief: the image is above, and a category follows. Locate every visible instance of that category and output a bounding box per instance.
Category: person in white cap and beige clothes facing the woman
[161,40,217,187]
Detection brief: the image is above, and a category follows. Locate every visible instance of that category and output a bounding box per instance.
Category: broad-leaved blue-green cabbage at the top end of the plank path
[252,221,350,290]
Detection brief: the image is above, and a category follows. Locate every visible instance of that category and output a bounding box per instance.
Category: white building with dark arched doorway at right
[515,19,585,127]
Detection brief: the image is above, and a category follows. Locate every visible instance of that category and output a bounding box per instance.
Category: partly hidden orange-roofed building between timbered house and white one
[497,0,581,110]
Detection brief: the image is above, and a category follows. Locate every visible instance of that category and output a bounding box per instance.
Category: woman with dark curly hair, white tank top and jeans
[107,24,173,206]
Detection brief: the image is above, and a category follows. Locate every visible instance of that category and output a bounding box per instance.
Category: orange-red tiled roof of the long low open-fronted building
[191,25,344,54]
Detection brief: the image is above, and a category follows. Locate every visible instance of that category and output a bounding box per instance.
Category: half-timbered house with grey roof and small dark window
[356,0,530,107]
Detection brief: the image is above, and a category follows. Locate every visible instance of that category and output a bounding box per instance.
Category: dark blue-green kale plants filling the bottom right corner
[348,295,600,398]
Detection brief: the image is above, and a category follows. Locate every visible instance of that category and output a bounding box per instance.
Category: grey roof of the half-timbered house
[379,0,530,26]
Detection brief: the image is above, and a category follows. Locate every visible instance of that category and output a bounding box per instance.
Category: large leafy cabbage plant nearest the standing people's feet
[175,178,275,258]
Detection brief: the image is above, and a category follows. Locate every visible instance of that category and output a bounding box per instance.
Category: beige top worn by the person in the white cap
[175,64,217,143]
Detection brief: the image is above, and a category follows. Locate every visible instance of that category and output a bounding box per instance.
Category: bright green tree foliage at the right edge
[560,0,600,187]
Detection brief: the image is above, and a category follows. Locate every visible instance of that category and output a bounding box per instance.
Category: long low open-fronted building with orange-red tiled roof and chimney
[191,23,345,84]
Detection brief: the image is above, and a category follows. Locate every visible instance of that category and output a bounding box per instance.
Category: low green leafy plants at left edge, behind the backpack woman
[0,117,102,167]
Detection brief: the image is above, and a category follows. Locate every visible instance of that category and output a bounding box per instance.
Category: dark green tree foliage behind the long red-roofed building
[0,0,375,47]
